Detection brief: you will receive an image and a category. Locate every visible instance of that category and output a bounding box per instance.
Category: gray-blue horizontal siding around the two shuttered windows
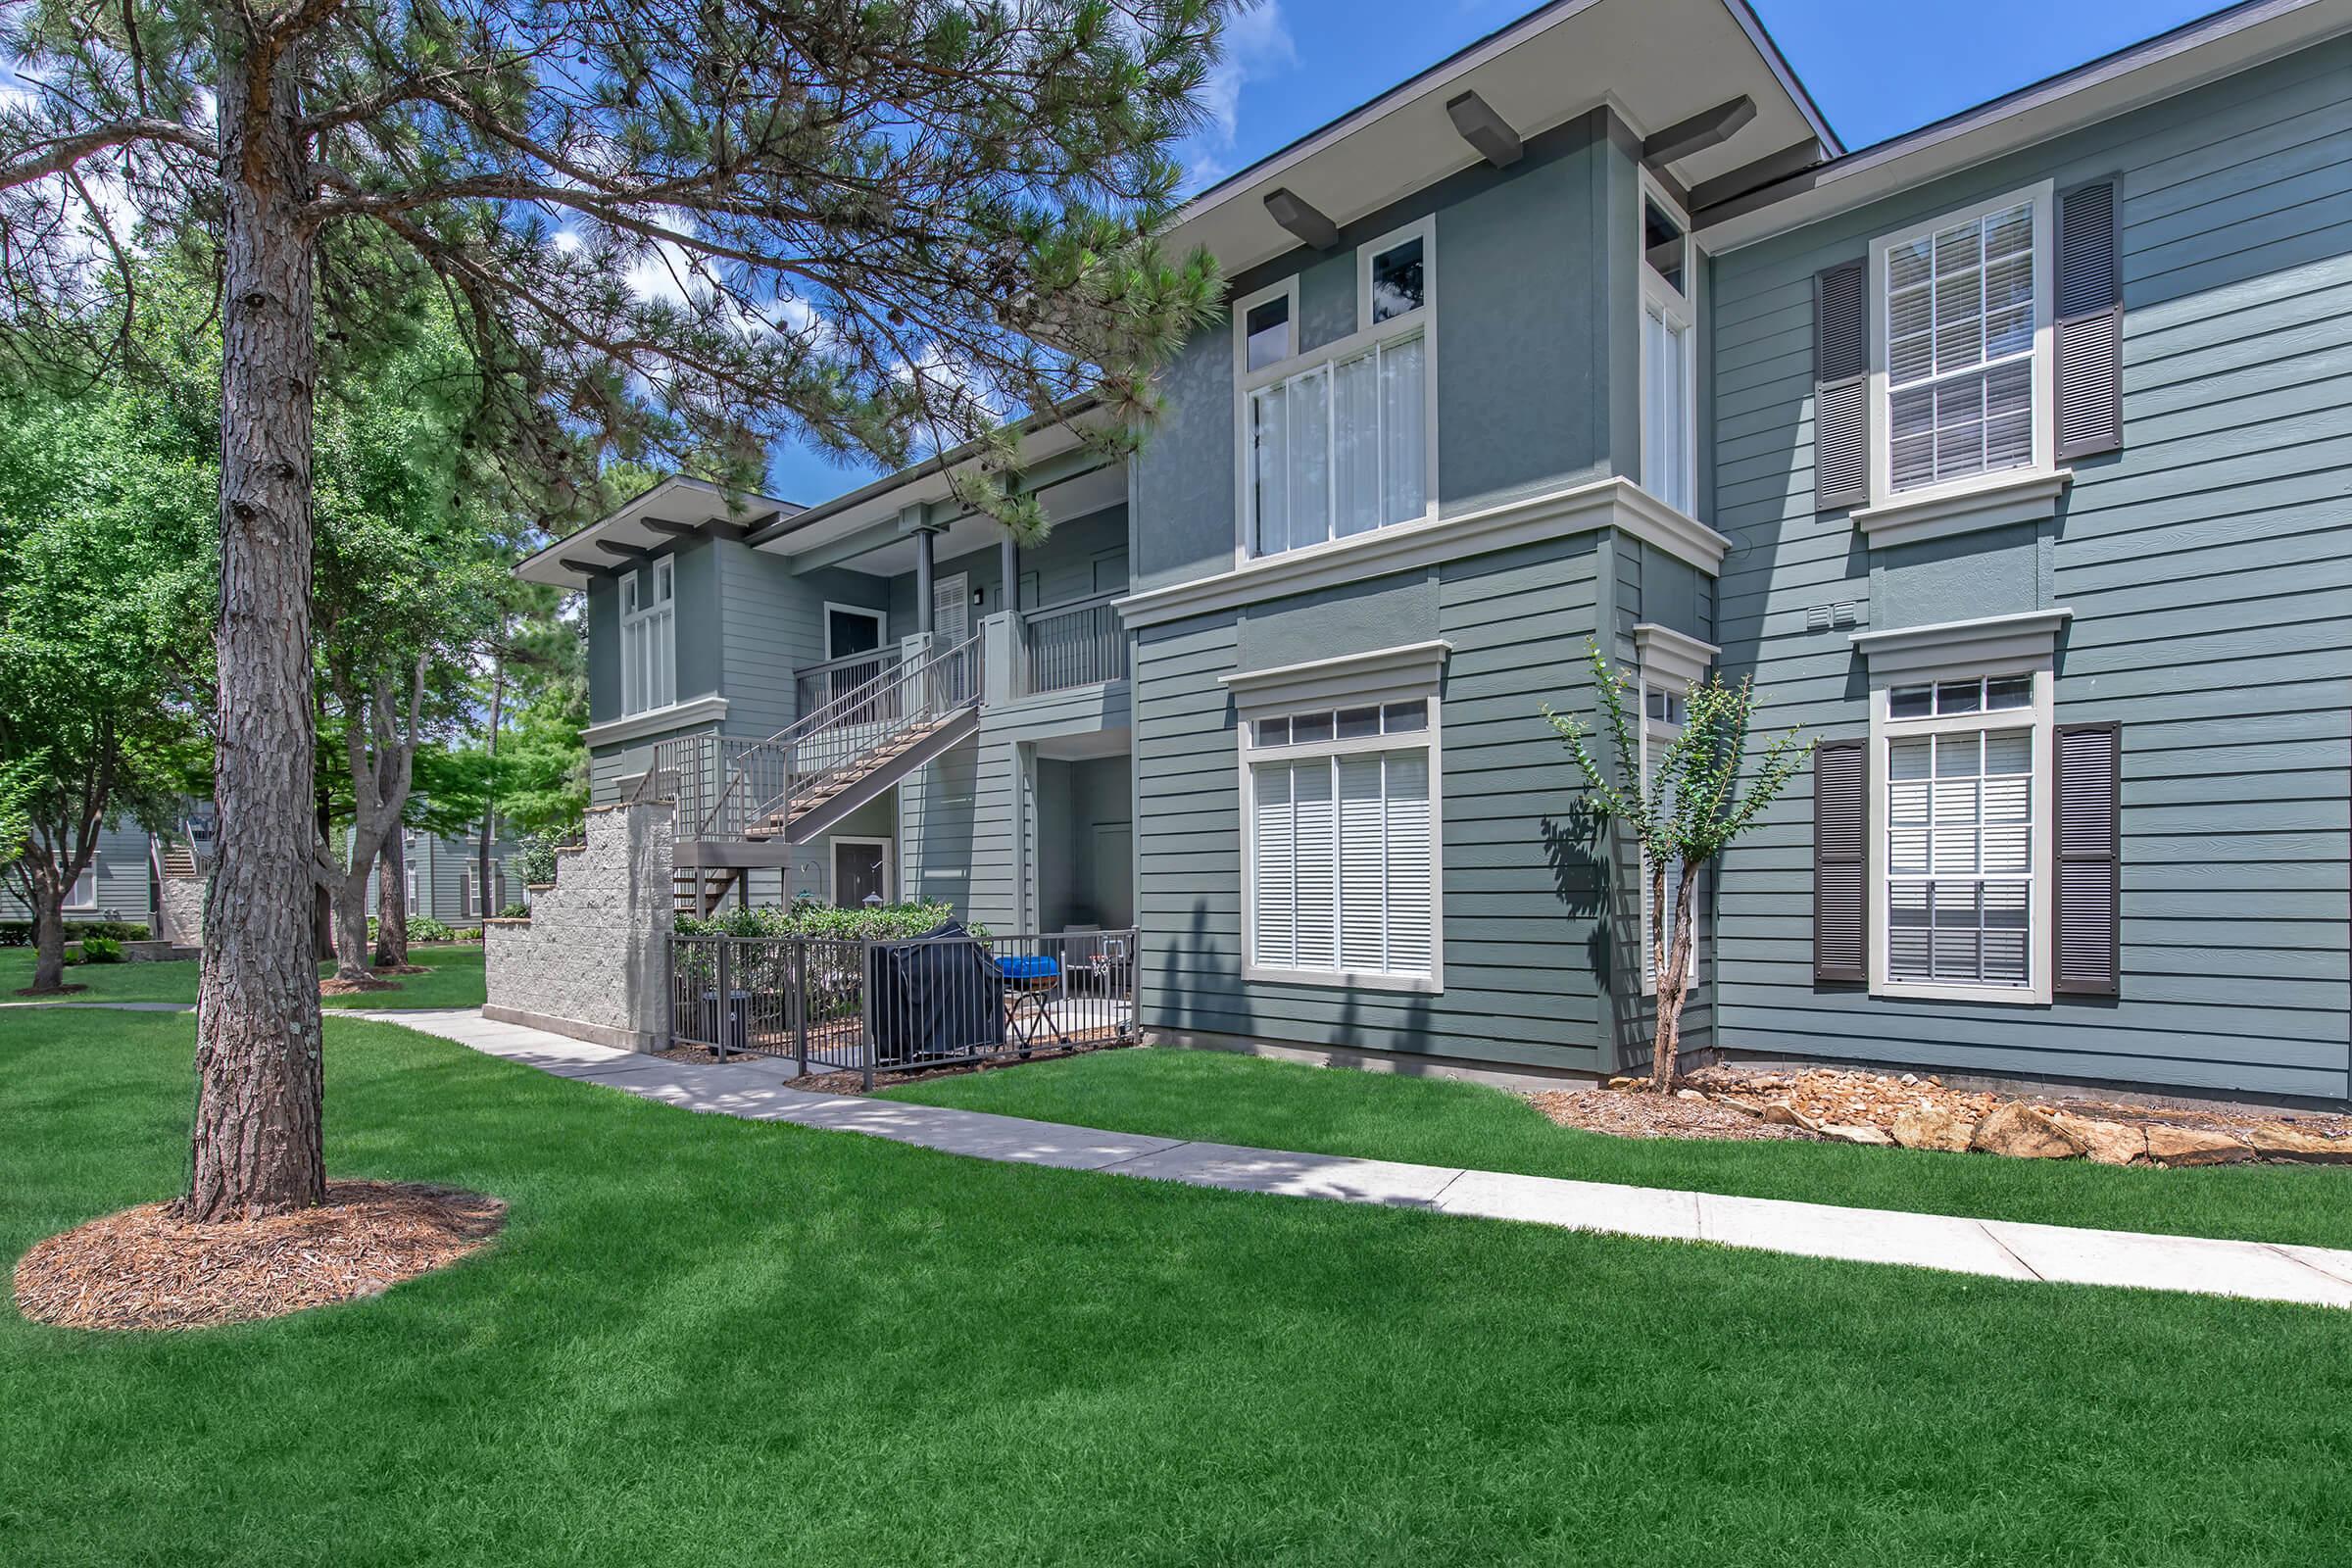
[1712,40,2352,1098]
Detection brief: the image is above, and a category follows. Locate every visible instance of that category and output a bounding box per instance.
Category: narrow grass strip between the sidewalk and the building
[887,1051,2352,1246]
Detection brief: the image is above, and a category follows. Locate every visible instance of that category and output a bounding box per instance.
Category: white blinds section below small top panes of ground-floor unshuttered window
[1249,748,1437,978]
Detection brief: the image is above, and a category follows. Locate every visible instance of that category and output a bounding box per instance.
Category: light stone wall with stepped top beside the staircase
[482,802,675,1051]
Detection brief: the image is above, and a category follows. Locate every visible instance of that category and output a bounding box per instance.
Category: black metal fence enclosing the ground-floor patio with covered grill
[670,929,1136,1089]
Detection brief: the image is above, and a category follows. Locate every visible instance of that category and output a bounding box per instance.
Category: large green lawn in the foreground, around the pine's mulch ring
[0,1013,2352,1568]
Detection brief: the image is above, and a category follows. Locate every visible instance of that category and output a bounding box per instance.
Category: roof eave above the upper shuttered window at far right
[1693,0,2352,252]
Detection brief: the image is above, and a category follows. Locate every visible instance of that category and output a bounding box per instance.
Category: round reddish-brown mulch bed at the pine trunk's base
[17,1183,506,1328]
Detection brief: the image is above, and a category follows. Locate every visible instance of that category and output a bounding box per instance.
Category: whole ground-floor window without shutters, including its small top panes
[1242,696,1442,990]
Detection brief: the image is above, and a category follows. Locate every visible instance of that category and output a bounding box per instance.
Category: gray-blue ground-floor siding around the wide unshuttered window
[1134,538,1606,1067]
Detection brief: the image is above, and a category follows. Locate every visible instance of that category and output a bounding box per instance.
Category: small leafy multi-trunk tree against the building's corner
[1543,647,1813,1093]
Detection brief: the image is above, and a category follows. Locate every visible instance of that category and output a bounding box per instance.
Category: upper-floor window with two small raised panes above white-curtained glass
[1235,219,1437,555]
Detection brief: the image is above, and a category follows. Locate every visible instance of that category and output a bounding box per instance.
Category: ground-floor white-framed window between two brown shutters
[1872,672,2051,1002]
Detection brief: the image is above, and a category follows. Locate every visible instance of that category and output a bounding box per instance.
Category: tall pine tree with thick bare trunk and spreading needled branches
[0,0,1225,1220]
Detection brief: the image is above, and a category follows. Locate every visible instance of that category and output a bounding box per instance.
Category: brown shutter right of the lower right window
[2051,724,2124,997]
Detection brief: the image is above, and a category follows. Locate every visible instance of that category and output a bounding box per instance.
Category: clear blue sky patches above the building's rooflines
[769,0,2218,503]
